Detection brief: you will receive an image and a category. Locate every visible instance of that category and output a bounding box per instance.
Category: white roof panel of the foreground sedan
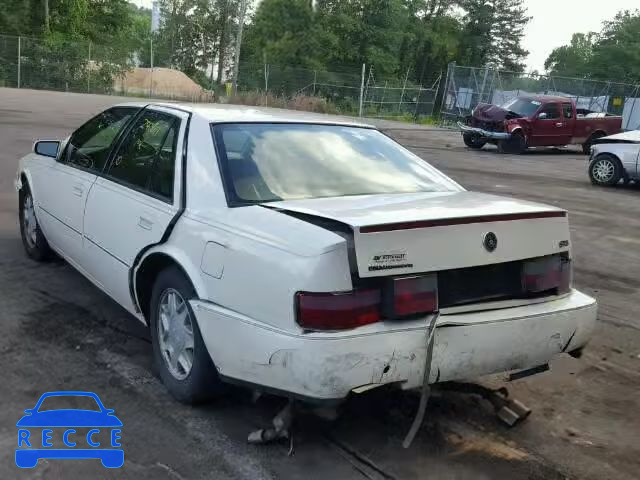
[119,102,374,128]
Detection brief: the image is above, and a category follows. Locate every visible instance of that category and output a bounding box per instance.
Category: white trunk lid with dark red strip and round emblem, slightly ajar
[266,192,569,277]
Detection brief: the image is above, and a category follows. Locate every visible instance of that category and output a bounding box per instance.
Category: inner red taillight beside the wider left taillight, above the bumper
[384,275,438,318]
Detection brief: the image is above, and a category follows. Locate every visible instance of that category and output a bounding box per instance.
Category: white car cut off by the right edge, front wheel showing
[588,130,640,186]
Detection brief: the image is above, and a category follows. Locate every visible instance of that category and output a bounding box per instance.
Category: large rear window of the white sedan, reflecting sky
[213,123,460,203]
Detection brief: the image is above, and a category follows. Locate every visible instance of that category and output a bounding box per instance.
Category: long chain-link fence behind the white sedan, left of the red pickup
[0,35,440,121]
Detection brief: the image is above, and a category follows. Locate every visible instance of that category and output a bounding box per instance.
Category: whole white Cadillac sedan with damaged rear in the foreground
[16,103,597,402]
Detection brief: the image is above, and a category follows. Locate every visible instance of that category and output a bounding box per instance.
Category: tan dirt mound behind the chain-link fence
[113,68,213,102]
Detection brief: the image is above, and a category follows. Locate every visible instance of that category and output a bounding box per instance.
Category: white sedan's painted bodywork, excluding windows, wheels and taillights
[16,104,597,401]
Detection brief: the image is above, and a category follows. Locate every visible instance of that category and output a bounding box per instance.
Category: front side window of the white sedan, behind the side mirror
[64,107,138,172]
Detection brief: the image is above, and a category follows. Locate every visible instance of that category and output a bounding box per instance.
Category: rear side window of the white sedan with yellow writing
[107,110,180,200]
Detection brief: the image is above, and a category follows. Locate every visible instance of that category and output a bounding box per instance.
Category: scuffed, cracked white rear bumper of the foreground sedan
[191,290,597,401]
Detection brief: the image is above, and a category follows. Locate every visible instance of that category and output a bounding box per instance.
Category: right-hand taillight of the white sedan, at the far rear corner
[522,255,571,293]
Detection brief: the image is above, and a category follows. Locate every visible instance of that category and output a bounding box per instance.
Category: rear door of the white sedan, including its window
[84,108,187,312]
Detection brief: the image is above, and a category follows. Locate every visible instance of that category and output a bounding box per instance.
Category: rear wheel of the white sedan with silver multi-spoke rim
[149,266,223,404]
